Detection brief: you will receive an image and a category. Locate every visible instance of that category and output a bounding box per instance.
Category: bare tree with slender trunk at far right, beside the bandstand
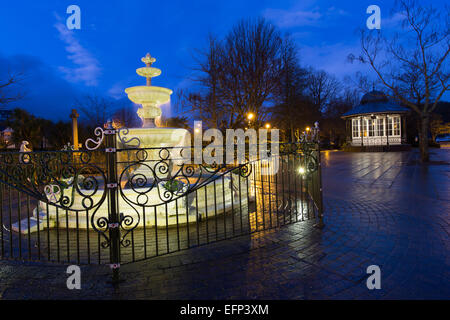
[349,0,450,162]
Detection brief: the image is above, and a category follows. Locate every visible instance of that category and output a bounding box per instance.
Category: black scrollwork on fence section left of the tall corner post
[0,151,106,210]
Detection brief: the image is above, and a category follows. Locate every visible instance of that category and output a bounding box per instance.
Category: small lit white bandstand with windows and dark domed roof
[342,91,409,147]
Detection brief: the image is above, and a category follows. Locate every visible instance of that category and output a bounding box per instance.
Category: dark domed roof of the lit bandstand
[342,90,409,118]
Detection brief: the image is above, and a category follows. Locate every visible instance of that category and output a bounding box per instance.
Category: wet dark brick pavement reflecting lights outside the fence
[0,149,450,299]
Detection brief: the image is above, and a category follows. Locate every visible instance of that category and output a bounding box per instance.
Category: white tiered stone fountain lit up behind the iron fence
[19,54,252,233]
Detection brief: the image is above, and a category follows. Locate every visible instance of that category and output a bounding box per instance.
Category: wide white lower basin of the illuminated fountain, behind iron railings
[26,175,255,233]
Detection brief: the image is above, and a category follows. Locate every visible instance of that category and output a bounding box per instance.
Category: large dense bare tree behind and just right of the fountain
[190,19,283,128]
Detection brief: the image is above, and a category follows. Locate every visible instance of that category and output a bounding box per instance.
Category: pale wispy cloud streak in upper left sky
[54,21,101,86]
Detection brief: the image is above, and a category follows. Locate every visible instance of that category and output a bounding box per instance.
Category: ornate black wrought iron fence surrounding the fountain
[0,128,323,280]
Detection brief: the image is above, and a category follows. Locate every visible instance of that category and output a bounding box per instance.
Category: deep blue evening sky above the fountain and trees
[0,0,445,120]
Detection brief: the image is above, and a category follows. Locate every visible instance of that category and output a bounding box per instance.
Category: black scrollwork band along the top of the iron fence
[0,120,319,255]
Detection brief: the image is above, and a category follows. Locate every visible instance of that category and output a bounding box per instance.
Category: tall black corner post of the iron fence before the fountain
[104,121,120,285]
